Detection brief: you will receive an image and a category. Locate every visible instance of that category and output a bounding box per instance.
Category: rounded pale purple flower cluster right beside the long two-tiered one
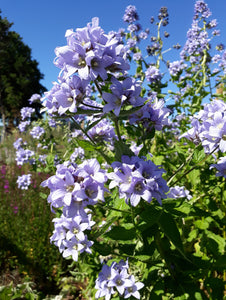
[108,156,169,206]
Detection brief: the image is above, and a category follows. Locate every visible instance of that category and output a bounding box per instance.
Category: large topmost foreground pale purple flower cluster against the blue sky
[54,18,129,80]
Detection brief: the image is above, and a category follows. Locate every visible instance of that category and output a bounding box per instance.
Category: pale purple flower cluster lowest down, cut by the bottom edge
[95,260,144,300]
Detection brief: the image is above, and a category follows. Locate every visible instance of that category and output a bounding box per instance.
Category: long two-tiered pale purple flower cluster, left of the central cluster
[42,159,107,261]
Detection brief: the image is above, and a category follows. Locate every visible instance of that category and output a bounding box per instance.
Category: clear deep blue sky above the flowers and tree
[0,0,226,89]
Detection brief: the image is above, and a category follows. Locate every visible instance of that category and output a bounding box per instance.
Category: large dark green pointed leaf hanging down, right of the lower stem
[158,211,184,256]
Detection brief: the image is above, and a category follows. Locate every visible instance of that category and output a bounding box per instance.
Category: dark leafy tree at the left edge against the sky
[0,10,46,139]
